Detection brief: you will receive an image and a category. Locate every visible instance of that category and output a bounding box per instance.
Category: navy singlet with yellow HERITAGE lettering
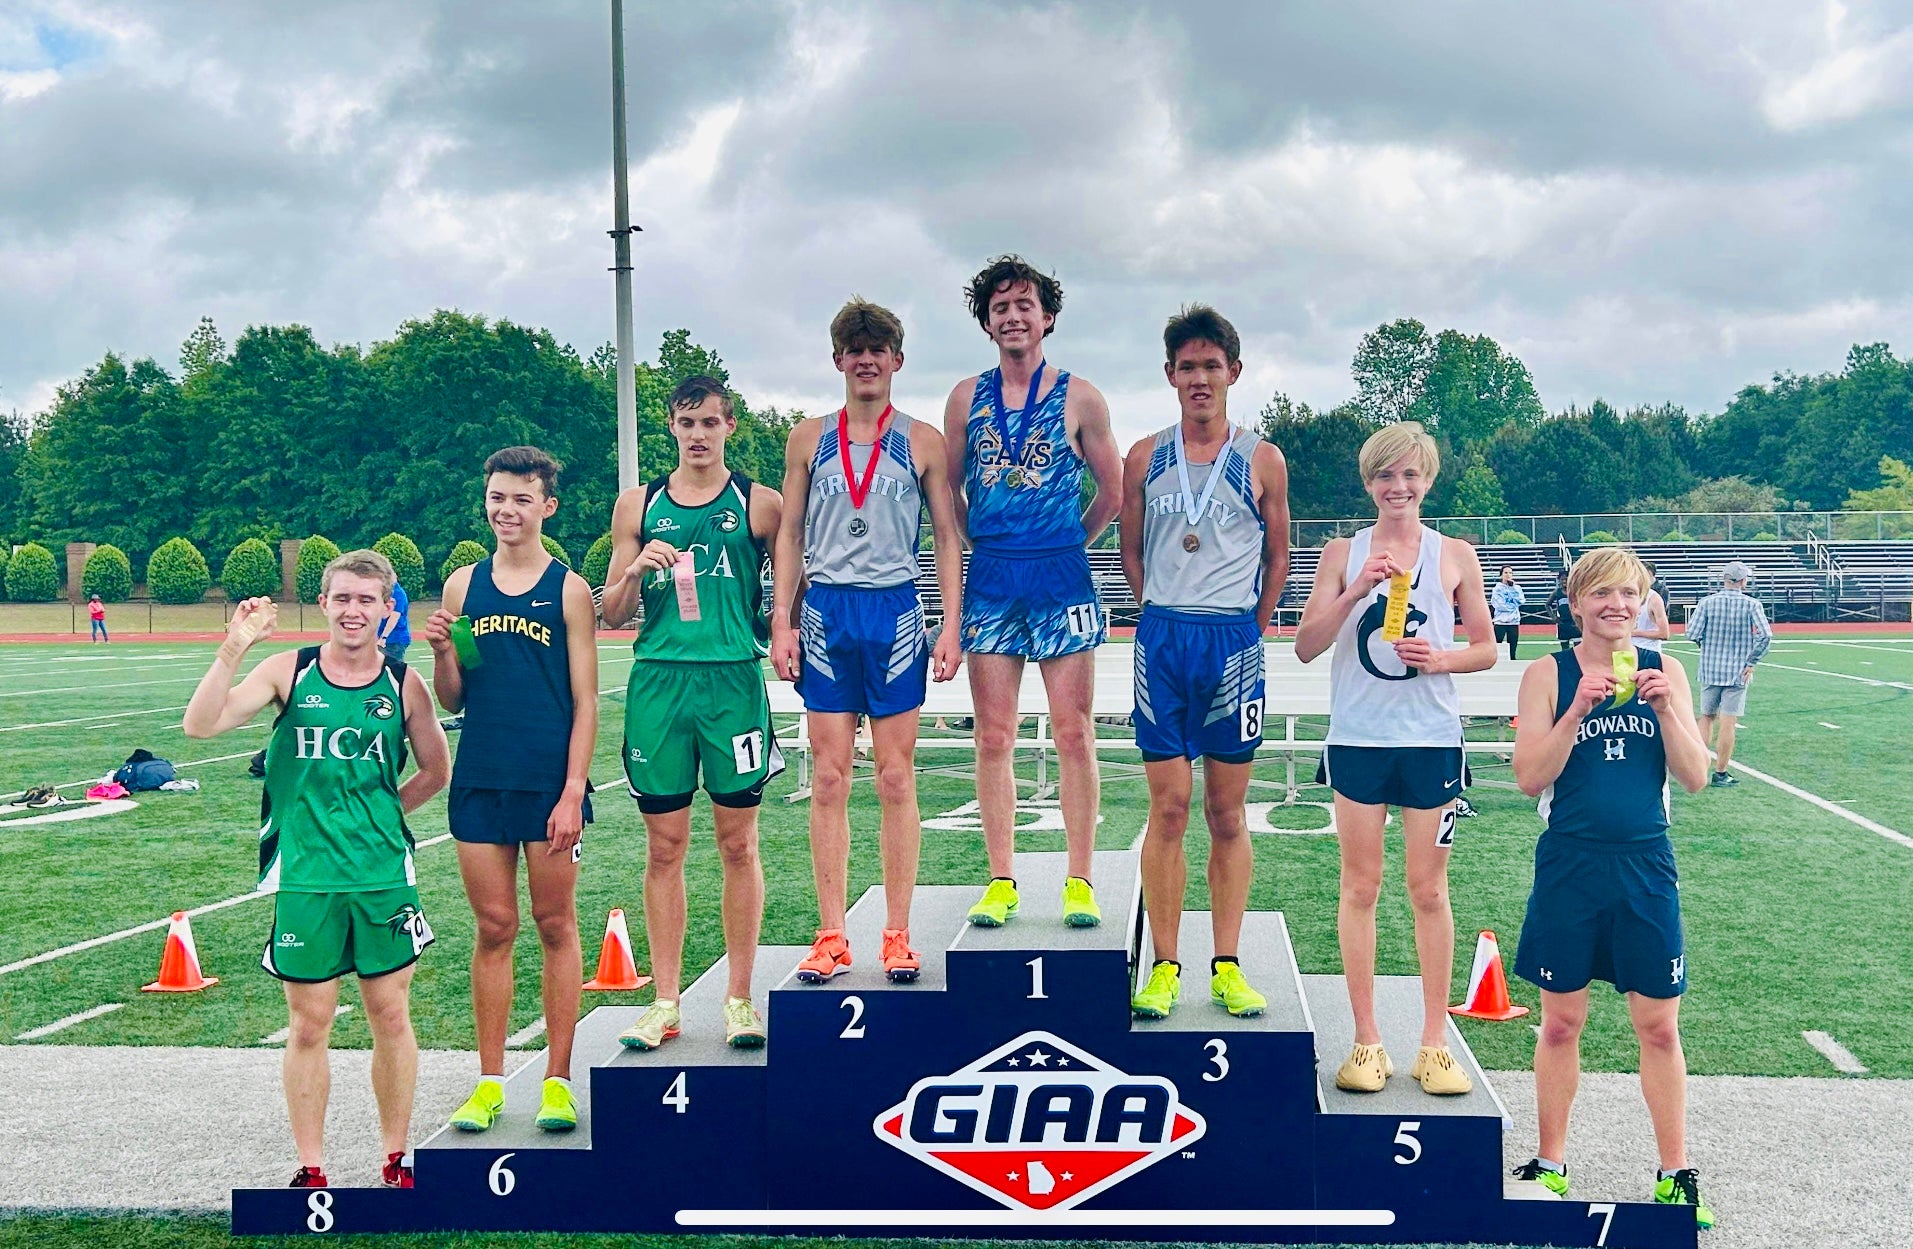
[451,559,572,794]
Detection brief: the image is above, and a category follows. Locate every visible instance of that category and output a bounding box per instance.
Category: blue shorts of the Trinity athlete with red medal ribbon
[798,581,930,719]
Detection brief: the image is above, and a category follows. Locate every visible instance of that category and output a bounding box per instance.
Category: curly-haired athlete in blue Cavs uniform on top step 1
[943,256,1123,928]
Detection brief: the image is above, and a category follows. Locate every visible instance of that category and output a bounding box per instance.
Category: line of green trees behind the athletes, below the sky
[0,310,1913,581]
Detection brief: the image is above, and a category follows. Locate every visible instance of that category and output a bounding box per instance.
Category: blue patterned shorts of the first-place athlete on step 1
[962,547,1110,660]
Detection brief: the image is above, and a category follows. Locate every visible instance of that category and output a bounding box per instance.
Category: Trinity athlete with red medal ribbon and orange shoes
[771,298,962,983]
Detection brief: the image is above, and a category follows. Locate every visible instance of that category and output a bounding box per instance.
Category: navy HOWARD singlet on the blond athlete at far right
[1540,648,1668,849]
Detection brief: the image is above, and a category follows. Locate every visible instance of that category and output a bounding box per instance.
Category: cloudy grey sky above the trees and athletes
[0,0,1913,447]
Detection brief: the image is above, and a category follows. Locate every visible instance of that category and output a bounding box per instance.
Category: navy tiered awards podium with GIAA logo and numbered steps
[233,851,1697,1249]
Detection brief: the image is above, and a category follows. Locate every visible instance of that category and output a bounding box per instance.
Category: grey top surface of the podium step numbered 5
[1303,975,1511,1127]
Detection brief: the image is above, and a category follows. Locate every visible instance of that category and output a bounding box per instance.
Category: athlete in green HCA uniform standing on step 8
[184,551,451,1188]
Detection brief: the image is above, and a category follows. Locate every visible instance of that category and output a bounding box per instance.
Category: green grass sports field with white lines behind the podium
[0,635,1913,1077]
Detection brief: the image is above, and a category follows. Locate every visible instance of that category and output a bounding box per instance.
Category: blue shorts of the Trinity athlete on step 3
[1134,604,1263,763]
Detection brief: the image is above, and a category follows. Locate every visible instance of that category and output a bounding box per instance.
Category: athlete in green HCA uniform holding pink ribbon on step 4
[599,377,784,1050]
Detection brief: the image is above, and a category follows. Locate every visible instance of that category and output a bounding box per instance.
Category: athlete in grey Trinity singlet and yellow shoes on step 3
[1123,304,1289,1019]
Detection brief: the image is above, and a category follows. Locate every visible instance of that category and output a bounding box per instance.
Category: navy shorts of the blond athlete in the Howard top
[1515,832,1687,998]
